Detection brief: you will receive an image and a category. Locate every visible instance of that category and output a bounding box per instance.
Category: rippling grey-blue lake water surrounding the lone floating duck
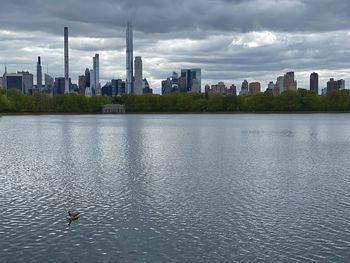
[0,114,350,262]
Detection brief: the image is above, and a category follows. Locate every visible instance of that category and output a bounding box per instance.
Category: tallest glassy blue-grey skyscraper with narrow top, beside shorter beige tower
[126,22,134,93]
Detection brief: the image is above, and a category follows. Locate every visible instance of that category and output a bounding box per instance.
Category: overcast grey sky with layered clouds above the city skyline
[0,0,350,94]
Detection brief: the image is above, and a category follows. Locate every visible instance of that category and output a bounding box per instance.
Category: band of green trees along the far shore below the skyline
[0,89,350,113]
